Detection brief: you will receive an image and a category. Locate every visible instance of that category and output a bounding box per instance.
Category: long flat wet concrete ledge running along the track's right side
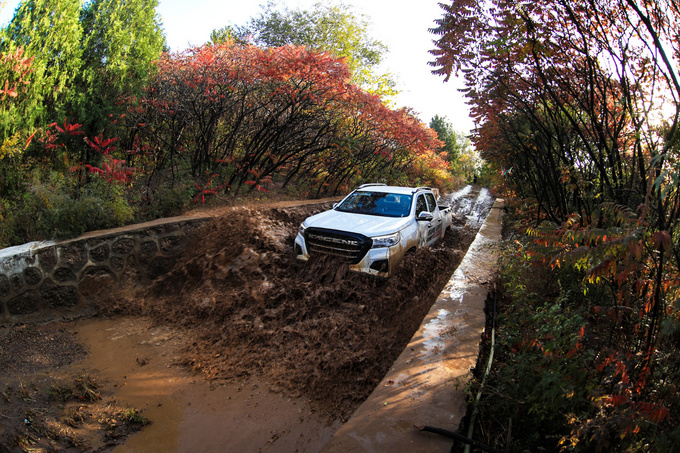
[321,199,504,453]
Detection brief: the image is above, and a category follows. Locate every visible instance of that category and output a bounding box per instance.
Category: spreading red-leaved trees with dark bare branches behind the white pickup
[130,43,447,193]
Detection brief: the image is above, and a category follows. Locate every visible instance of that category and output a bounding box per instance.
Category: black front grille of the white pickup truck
[305,227,373,264]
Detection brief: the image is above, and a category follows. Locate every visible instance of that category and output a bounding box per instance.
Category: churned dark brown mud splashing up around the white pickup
[105,205,476,419]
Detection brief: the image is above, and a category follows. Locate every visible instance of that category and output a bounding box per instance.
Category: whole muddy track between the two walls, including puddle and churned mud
[0,185,488,452]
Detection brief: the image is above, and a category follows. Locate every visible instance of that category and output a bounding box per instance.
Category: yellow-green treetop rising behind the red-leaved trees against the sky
[220,1,396,97]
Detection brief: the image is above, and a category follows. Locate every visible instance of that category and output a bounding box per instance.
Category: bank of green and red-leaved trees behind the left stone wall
[0,0,472,247]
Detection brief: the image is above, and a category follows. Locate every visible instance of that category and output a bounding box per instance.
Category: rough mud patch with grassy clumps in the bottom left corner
[0,324,149,452]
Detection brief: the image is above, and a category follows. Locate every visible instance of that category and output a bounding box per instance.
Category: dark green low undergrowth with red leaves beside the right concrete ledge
[469,224,680,452]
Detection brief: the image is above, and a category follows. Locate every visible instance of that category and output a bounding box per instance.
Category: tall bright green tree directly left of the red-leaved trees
[79,0,165,135]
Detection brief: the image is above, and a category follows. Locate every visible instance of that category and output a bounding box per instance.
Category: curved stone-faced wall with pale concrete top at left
[0,217,208,327]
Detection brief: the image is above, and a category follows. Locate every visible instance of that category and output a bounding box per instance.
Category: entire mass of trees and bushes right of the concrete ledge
[432,0,680,452]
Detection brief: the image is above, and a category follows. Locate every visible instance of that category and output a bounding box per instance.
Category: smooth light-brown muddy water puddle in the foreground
[71,317,340,453]
